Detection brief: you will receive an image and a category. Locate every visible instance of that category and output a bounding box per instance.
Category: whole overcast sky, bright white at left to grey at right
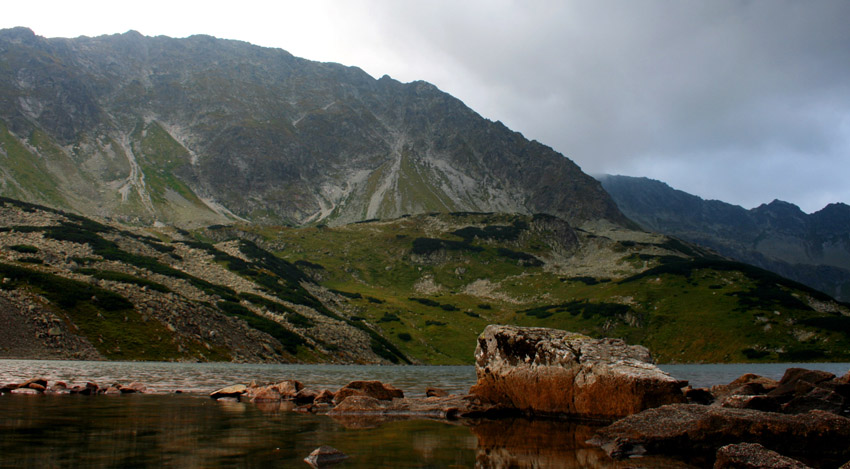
[0,0,850,212]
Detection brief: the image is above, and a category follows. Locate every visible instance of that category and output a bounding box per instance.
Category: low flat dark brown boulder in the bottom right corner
[591,404,850,466]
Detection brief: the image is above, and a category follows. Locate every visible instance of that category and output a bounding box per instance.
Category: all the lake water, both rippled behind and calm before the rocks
[0,360,850,468]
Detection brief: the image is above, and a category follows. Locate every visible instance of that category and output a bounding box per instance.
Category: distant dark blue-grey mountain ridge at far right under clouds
[599,176,850,301]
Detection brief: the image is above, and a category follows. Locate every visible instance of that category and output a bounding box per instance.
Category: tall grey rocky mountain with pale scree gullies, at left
[0,28,627,227]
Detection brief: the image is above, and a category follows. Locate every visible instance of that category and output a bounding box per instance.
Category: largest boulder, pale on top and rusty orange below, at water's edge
[470,325,685,419]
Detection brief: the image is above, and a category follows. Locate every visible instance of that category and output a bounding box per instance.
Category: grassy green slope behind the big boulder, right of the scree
[234,214,850,364]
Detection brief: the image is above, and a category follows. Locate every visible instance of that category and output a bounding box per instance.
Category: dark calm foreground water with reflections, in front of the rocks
[0,395,704,468]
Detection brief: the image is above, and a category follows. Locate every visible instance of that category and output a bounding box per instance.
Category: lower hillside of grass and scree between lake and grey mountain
[0,199,850,364]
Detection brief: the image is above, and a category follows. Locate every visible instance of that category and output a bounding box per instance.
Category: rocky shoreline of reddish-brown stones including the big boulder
[0,326,850,468]
